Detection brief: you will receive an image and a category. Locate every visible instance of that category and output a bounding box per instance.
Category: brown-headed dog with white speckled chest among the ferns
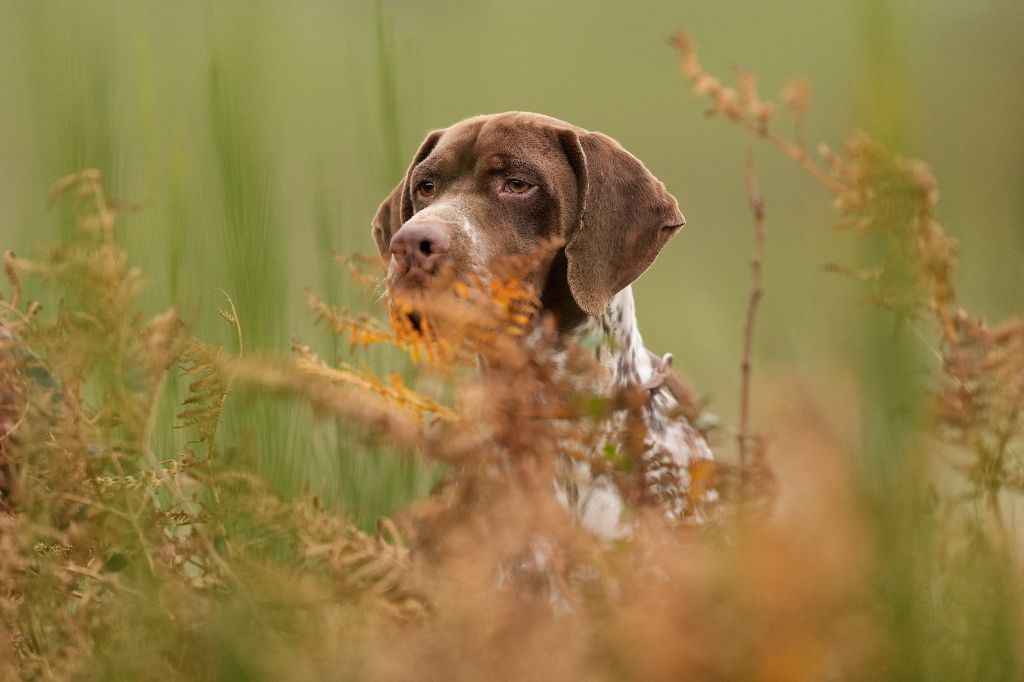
[373,112,711,538]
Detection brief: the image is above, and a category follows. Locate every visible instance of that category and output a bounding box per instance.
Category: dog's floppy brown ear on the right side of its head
[559,129,685,315]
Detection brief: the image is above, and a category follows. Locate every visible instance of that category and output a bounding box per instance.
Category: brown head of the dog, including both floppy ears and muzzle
[373,112,685,315]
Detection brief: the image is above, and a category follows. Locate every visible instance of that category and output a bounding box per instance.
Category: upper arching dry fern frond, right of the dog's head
[673,32,958,342]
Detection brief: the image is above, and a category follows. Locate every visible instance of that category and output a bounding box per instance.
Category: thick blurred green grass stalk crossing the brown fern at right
[857,5,935,680]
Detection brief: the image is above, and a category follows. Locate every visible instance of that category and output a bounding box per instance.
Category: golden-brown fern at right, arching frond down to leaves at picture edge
[674,32,1024,527]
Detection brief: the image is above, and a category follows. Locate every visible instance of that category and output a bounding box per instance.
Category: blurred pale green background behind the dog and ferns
[0,0,1024,521]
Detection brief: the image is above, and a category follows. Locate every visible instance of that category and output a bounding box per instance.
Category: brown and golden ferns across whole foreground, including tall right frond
[0,35,1024,680]
